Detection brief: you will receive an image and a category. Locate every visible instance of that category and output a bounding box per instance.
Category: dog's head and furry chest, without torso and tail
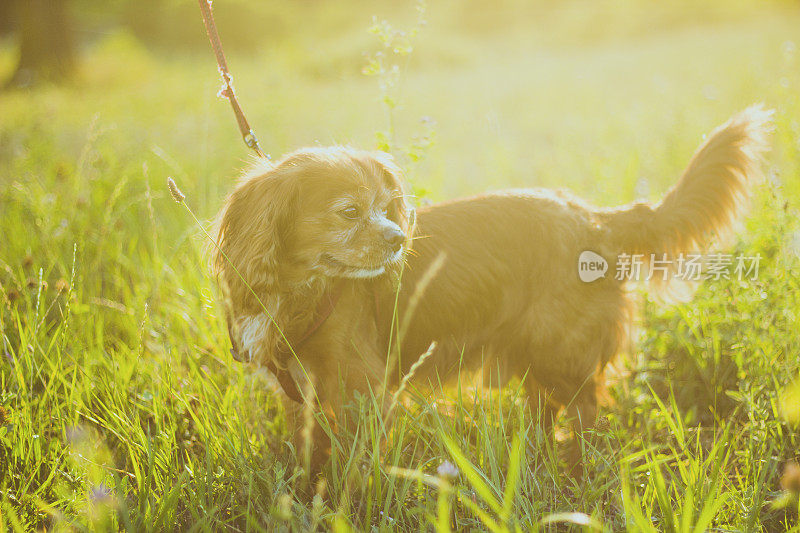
[214,147,414,426]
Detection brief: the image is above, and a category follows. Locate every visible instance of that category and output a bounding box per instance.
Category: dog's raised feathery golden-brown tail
[599,105,773,257]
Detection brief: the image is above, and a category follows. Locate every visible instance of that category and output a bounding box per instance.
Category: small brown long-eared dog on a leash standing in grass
[215,106,771,466]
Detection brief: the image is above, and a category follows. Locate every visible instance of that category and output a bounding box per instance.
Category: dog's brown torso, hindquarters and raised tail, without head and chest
[387,107,771,424]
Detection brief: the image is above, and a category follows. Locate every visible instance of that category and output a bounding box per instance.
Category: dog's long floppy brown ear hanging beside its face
[214,162,297,315]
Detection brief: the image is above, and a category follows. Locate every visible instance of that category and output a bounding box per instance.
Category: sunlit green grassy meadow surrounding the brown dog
[0,2,800,531]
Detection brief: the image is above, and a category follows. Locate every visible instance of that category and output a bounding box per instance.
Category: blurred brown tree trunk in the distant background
[8,0,75,87]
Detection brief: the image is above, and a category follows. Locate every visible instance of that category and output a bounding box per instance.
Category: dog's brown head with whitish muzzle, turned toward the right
[215,147,414,310]
